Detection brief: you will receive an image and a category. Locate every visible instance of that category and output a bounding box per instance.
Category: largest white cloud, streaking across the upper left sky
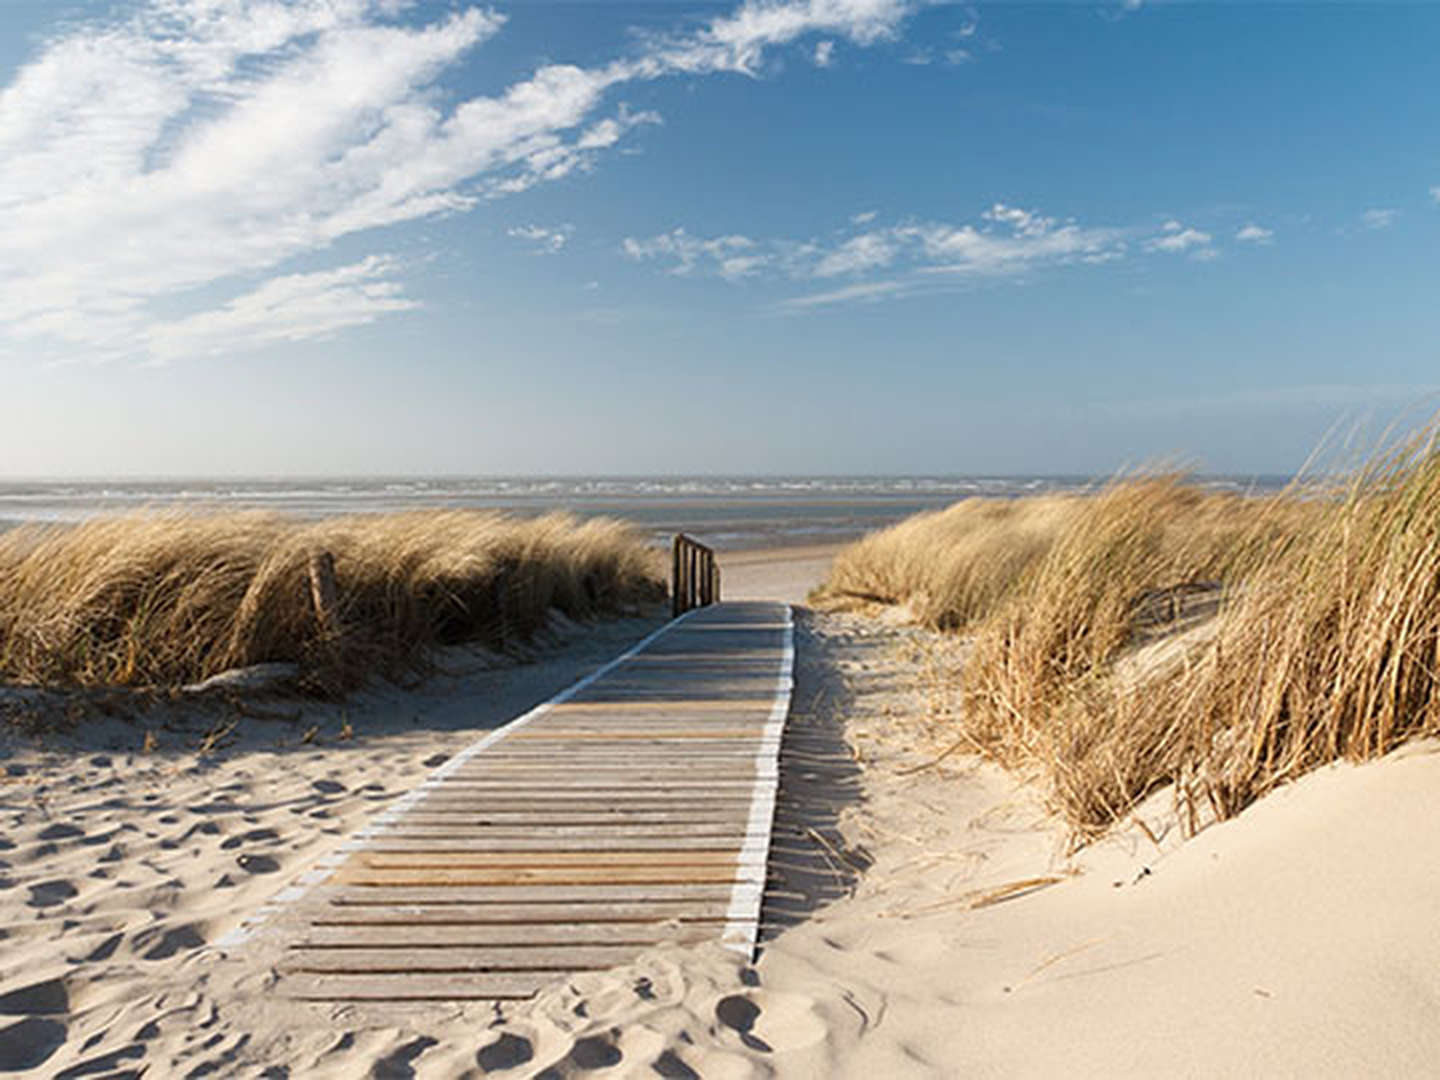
[0,0,910,359]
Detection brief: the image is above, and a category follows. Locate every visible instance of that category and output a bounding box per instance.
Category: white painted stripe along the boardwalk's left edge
[207,608,708,953]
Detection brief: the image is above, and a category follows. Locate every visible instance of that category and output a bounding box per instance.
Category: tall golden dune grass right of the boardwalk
[816,428,1440,840]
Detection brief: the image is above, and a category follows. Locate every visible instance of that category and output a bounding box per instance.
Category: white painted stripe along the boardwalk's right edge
[720,605,795,962]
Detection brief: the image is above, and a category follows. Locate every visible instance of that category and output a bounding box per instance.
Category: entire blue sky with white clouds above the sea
[0,0,1440,477]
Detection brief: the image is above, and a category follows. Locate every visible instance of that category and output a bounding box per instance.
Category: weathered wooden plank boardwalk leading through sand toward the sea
[240,603,793,1001]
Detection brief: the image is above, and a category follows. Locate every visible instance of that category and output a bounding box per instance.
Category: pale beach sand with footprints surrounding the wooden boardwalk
[0,552,1440,1080]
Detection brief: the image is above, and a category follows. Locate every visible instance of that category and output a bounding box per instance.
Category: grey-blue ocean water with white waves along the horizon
[0,475,1284,550]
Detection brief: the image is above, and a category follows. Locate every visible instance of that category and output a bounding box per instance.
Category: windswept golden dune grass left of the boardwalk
[0,511,664,690]
